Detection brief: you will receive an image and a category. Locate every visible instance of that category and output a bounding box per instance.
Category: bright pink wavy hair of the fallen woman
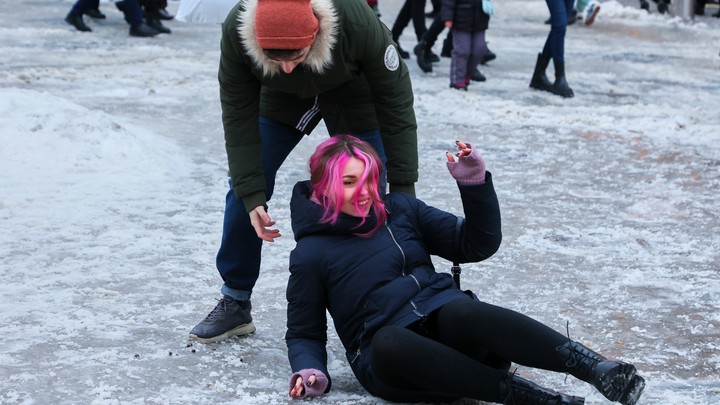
[310,135,387,236]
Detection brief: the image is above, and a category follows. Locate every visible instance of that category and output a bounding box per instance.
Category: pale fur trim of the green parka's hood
[237,0,339,77]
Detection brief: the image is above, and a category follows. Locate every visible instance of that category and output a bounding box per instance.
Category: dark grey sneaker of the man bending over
[190,295,255,343]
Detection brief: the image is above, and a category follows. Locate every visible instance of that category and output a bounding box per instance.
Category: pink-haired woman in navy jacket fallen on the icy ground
[286,135,645,405]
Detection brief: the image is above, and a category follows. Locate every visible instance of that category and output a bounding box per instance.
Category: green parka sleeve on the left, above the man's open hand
[218,7,266,211]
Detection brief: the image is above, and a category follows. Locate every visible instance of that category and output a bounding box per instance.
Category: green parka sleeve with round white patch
[343,2,418,195]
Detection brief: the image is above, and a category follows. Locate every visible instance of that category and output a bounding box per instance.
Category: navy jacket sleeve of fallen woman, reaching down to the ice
[285,245,332,392]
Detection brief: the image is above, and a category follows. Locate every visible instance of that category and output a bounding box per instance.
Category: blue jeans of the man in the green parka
[216,117,386,301]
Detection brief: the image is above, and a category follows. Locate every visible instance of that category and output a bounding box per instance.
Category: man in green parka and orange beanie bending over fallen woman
[190,0,418,342]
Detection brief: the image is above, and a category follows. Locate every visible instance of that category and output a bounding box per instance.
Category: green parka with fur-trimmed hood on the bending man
[218,0,418,211]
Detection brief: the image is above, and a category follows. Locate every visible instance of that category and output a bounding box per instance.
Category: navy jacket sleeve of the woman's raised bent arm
[418,172,502,263]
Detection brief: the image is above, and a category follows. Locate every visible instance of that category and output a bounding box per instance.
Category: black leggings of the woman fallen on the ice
[370,299,568,402]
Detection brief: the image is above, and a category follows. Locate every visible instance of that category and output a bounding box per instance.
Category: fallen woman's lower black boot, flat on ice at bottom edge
[497,374,585,405]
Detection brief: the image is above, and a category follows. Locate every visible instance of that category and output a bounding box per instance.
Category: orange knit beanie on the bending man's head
[255,0,320,49]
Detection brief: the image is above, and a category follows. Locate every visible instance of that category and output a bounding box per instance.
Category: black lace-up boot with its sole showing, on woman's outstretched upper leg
[555,341,645,405]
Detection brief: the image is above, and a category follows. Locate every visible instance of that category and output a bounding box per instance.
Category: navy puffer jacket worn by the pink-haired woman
[285,172,501,392]
